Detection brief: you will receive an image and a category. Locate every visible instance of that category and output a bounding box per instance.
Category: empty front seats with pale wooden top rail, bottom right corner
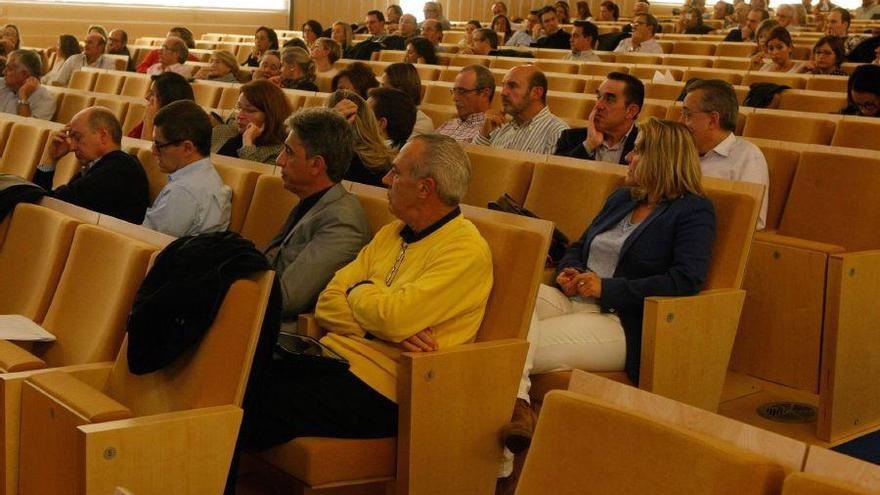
[517,372,880,495]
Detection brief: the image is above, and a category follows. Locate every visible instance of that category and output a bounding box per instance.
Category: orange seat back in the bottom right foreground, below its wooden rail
[516,391,785,495]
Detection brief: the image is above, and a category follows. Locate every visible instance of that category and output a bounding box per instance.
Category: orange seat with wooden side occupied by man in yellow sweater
[258,184,551,493]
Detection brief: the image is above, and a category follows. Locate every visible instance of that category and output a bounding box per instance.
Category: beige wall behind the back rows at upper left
[0,0,288,47]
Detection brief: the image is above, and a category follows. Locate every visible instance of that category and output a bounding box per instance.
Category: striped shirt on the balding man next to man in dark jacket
[474,106,568,154]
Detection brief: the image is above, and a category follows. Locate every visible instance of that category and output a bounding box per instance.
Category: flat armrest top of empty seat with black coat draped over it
[28,371,131,423]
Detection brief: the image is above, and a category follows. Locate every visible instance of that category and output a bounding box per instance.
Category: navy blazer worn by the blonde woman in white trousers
[557,187,715,384]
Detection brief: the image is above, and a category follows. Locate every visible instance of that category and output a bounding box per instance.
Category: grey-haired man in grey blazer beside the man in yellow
[266,108,371,333]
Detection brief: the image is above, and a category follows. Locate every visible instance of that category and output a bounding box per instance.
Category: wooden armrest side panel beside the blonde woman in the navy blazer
[639,289,746,411]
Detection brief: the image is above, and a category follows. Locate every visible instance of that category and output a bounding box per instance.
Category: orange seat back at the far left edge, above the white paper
[0,204,80,323]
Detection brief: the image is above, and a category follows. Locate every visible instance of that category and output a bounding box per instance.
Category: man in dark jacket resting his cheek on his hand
[556,72,645,165]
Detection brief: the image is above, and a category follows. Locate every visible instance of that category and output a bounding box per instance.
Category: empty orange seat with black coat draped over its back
[19,272,274,495]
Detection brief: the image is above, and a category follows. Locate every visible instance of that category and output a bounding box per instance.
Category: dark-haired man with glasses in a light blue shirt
[143,100,232,237]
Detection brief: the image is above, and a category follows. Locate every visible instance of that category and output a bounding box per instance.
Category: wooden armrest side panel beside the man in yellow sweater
[397,339,528,493]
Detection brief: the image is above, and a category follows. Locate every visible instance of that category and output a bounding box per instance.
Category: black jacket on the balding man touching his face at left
[34,150,150,224]
